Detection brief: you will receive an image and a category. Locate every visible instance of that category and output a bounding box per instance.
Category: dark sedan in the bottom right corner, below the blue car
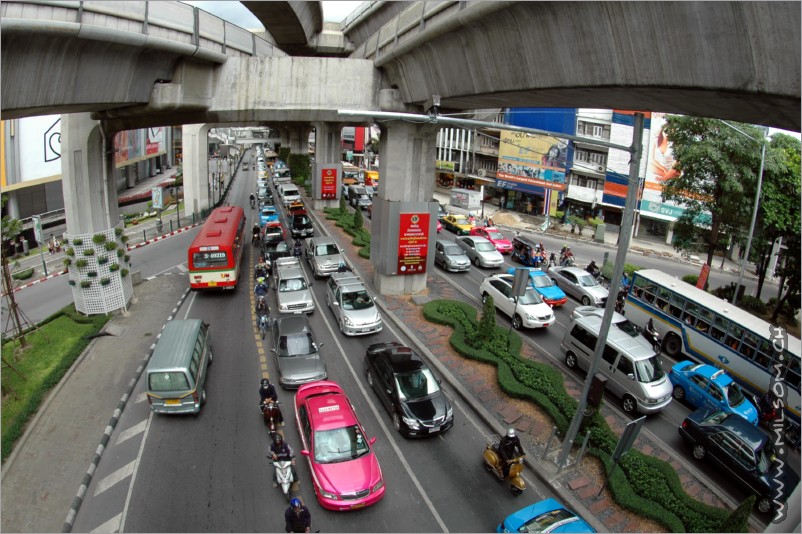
[679,407,799,514]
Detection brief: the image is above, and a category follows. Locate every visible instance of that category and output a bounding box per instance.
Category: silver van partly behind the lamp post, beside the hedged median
[560,315,672,414]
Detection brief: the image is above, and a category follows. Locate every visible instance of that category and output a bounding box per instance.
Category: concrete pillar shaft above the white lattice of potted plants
[61,113,119,235]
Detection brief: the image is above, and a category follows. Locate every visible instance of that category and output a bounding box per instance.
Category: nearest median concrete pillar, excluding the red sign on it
[370,121,438,295]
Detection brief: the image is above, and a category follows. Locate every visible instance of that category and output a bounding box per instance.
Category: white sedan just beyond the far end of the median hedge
[479,274,557,330]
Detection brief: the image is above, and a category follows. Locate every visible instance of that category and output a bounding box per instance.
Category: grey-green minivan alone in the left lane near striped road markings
[145,319,212,414]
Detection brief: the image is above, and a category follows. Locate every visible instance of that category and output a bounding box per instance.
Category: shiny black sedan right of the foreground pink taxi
[365,342,454,438]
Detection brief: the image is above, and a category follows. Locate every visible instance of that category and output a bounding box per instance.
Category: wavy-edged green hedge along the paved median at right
[423,299,736,532]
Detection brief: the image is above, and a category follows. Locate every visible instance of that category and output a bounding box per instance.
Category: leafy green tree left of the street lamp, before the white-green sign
[663,115,763,266]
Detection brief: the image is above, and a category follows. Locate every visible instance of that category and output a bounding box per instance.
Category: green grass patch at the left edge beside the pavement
[0,310,109,462]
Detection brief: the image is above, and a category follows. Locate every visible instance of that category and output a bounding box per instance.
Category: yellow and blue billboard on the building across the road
[496,130,568,191]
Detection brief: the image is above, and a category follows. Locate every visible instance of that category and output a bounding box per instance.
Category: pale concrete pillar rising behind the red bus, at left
[181,124,212,217]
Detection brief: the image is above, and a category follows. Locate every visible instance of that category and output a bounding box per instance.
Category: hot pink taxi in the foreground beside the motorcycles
[295,380,385,511]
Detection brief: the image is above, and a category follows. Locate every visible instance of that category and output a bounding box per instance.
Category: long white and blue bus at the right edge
[626,269,802,428]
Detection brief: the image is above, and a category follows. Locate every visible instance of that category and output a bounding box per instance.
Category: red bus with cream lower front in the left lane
[187,206,245,290]
